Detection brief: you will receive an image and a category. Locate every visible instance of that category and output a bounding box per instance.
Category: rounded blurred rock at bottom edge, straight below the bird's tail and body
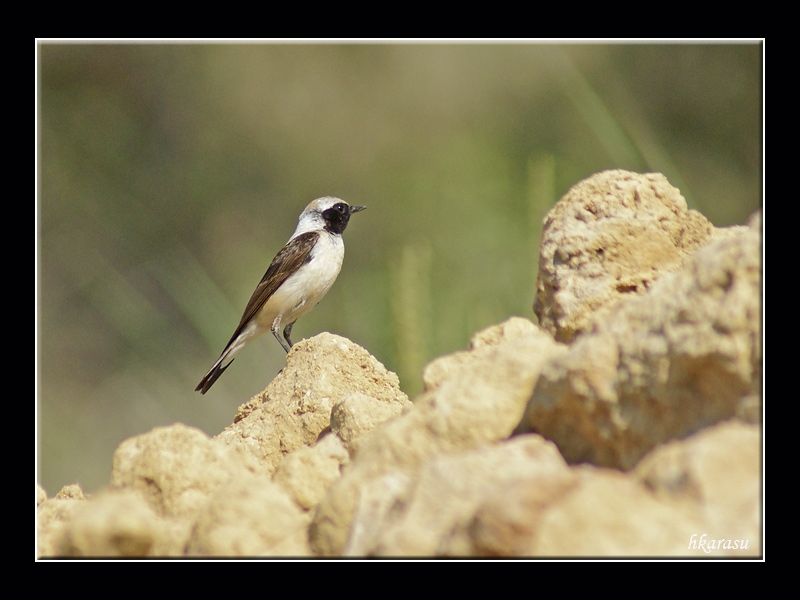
[187,473,309,556]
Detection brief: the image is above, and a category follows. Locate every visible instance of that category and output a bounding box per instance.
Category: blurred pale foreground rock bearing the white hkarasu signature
[462,422,761,557]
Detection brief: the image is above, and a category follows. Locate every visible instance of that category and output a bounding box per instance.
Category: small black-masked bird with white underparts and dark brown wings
[195,196,366,394]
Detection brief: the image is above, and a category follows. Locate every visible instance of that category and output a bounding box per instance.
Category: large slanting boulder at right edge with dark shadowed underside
[518,218,762,469]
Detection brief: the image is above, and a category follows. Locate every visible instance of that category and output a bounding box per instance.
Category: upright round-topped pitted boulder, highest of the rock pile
[533,170,713,342]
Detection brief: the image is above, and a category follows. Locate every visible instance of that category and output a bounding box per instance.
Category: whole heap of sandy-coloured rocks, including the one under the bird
[37,171,763,558]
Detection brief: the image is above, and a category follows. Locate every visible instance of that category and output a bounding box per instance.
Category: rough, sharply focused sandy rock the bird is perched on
[215,333,408,473]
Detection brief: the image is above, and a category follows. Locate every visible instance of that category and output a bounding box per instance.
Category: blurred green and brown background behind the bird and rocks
[36,43,763,495]
